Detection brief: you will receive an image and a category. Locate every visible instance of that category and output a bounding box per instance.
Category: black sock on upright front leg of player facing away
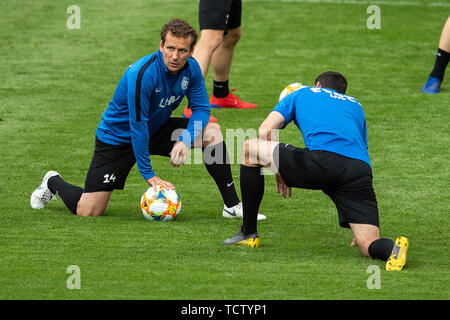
[240,164,264,235]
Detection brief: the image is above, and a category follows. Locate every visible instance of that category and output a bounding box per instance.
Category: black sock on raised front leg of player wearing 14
[203,141,240,208]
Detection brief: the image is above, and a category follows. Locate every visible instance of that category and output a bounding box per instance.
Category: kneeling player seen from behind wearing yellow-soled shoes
[223,71,408,270]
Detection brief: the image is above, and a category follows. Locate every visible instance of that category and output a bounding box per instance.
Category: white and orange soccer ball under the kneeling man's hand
[141,185,181,221]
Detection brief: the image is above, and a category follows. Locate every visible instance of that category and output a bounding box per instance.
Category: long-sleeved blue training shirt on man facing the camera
[96,50,211,180]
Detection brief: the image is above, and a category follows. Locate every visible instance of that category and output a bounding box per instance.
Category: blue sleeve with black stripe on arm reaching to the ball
[127,65,155,180]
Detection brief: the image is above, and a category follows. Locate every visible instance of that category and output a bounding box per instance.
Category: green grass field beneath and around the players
[0,0,450,300]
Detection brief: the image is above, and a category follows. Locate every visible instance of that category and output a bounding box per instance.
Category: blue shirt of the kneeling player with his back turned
[273,87,371,166]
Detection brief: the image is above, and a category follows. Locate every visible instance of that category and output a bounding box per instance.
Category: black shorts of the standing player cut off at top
[198,0,242,32]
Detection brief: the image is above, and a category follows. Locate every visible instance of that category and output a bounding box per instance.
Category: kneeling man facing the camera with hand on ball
[30,19,268,218]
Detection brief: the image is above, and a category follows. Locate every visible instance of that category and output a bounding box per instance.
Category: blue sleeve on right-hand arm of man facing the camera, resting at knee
[178,59,211,148]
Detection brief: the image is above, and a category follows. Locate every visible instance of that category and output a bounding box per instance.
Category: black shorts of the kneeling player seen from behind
[274,143,379,228]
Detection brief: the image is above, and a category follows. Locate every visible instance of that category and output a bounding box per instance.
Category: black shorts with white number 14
[84,118,189,192]
